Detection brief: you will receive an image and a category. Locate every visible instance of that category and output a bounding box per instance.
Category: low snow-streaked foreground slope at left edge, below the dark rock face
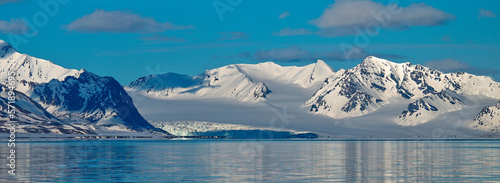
[0,85,94,134]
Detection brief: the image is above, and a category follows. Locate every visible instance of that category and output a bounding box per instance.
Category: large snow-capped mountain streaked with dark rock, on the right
[306,56,500,125]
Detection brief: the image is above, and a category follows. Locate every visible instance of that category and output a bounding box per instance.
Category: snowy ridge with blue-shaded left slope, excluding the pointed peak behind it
[126,65,271,102]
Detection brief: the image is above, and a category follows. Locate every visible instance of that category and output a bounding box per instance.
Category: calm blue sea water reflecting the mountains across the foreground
[0,140,500,182]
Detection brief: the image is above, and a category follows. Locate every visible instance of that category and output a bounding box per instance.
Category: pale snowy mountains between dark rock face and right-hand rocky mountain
[126,60,335,102]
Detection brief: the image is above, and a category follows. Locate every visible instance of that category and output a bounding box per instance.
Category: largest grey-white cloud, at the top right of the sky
[311,0,455,36]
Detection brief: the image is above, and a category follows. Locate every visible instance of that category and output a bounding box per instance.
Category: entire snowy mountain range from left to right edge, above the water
[0,41,500,138]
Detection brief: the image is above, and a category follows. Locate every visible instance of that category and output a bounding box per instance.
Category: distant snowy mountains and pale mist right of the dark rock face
[125,56,500,136]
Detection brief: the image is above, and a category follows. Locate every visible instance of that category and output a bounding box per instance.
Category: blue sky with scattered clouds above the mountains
[0,0,500,85]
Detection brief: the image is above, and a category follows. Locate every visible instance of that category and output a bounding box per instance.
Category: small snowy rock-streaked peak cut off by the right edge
[470,102,500,132]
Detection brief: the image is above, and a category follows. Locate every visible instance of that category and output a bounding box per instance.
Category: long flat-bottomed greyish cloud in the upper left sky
[65,9,193,33]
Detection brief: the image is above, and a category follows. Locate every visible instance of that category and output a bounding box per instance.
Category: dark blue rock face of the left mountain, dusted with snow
[31,72,160,131]
